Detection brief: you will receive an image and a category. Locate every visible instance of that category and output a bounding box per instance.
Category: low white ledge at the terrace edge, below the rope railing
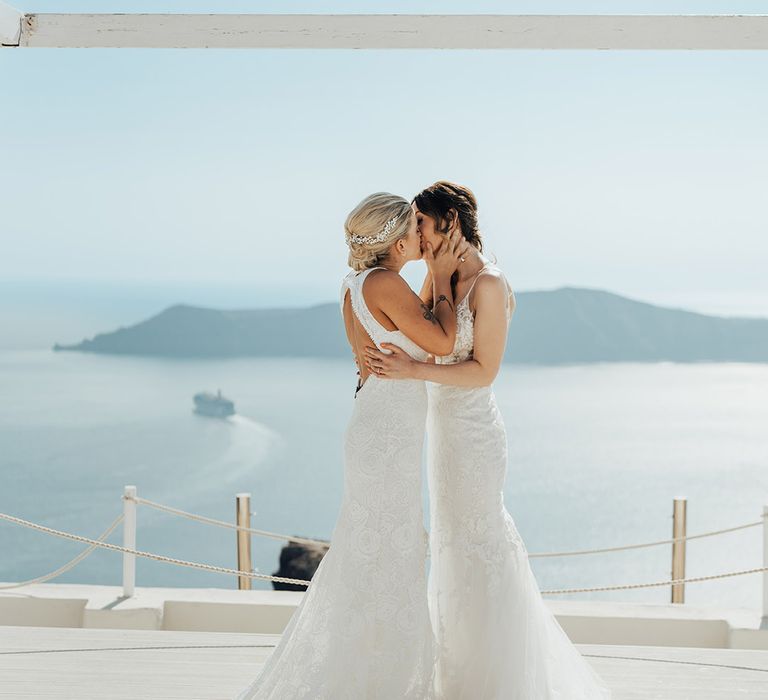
[0,584,768,649]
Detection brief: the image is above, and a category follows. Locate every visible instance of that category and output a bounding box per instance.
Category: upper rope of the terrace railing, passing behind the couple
[123,496,766,559]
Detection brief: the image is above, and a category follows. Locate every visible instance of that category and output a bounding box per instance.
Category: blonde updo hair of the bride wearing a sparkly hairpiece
[344,192,414,271]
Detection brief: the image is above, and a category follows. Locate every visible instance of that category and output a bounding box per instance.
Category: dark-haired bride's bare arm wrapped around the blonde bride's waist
[365,274,514,387]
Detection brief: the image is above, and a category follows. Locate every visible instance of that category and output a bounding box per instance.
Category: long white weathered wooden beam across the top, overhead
[9,14,768,50]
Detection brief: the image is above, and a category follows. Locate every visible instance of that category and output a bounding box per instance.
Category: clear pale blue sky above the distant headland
[0,0,768,316]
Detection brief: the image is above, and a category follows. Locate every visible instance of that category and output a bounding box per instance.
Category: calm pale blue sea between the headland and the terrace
[0,350,768,608]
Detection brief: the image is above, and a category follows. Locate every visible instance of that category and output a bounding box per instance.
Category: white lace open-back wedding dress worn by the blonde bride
[238,268,434,700]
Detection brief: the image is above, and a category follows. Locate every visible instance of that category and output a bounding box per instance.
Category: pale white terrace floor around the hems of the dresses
[0,627,768,700]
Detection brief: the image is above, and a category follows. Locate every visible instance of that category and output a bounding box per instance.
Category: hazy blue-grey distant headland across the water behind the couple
[53,287,768,365]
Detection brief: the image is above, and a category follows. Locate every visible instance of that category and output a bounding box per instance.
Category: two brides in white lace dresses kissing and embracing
[238,181,611,700]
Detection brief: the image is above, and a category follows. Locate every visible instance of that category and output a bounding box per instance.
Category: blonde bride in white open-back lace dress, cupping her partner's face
[238,193,468,700]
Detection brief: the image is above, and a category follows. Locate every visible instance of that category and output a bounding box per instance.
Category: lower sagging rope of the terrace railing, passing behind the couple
[0,513,768,595]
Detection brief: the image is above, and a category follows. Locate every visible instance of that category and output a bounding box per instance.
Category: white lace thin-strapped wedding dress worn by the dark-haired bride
[427,264,610,700]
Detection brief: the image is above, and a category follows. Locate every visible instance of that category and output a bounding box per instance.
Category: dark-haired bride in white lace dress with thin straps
[366,182,611,700]
